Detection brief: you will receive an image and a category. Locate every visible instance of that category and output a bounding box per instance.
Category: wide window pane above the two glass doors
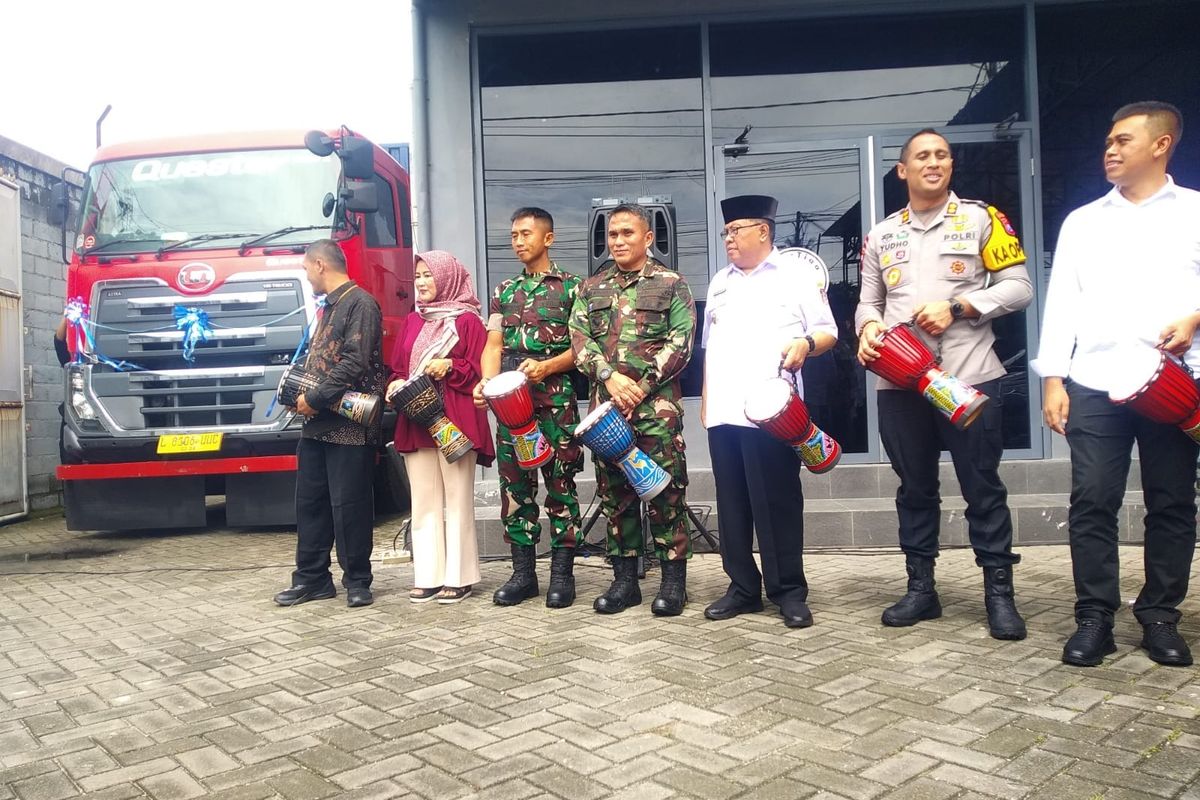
[709,8,1027,144]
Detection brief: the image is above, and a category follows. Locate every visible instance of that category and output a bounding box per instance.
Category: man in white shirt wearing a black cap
[700,194,838,627]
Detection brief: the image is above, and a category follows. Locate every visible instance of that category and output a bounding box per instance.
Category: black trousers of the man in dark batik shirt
[292,439,374,589]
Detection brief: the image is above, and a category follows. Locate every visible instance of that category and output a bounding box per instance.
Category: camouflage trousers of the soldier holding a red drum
[496,386,583,549]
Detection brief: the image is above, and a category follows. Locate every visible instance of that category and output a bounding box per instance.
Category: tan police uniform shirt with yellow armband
[854,192,1033,389]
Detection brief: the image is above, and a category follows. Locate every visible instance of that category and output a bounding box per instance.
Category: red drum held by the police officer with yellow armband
[866,323,989,431]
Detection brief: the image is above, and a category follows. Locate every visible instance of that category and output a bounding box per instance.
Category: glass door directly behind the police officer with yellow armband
[875,125,1043,458]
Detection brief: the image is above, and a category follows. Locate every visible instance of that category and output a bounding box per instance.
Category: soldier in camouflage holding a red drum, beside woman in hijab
[475,207,583,608]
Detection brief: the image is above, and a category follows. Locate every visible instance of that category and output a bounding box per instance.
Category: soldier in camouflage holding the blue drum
[570,205,696,616]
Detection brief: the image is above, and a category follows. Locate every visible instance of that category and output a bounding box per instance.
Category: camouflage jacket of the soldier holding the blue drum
[570,258,696,417]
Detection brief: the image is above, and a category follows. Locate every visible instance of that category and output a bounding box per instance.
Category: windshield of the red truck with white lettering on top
[76,149,340,253]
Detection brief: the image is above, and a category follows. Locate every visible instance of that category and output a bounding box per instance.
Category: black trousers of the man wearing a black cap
[708,425,809,604]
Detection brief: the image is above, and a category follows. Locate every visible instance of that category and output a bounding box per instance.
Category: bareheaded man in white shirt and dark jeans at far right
[1032,102,1200,667]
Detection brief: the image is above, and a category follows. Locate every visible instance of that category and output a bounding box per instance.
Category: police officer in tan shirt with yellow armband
[854,128,1033,639]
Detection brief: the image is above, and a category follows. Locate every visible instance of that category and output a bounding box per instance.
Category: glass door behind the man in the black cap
[701,137,881,463]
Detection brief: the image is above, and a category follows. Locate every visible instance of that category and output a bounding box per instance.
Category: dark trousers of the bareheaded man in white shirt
[1067,380,1198,625]
